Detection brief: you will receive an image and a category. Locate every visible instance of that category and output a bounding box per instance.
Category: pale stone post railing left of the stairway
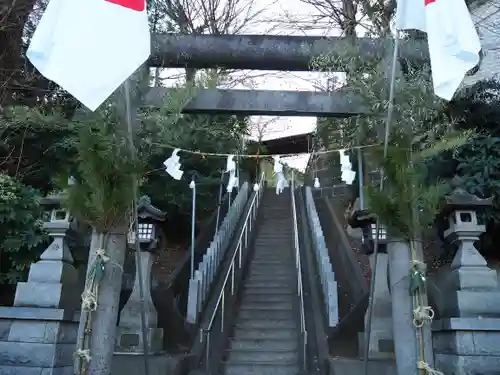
[186,182,249,324]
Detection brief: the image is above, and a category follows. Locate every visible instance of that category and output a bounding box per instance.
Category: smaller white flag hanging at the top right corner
[396,0,481,100]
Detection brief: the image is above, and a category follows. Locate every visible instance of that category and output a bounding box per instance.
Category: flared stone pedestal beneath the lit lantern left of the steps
[116,251,163,353]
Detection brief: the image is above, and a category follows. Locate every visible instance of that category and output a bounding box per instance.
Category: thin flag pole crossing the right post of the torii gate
[363,29,404,375]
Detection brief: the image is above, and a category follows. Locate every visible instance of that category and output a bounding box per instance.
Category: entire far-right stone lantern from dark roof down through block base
[433,189,500,375]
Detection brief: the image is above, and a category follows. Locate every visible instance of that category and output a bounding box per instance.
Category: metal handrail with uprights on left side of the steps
[200,173,264,369]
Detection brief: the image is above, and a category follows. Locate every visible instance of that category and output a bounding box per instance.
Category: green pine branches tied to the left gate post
[67,107,141,233]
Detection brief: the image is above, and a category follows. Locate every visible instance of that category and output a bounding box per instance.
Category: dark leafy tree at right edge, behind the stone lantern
[427,79,500,258]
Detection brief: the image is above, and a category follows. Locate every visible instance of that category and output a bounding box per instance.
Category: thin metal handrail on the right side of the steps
[290,170,307,370]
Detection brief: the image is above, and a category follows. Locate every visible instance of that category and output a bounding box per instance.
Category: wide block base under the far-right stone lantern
[433,318,500,375]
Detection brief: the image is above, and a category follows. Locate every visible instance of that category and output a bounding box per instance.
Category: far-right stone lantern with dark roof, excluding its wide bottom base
[440,188,500,317]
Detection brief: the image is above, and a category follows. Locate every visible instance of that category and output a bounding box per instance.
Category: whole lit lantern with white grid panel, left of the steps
[116,196,165,353]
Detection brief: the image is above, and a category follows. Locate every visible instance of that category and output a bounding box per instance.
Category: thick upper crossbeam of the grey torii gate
[149,34,428,71]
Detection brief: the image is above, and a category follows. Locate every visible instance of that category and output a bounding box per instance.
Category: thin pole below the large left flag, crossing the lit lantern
[123,79,149,375]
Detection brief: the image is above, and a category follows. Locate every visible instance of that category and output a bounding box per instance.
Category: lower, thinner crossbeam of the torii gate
[145,87,367,117]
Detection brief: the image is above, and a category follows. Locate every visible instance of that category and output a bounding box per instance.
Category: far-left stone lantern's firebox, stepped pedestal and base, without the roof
[0,197,79,375]
